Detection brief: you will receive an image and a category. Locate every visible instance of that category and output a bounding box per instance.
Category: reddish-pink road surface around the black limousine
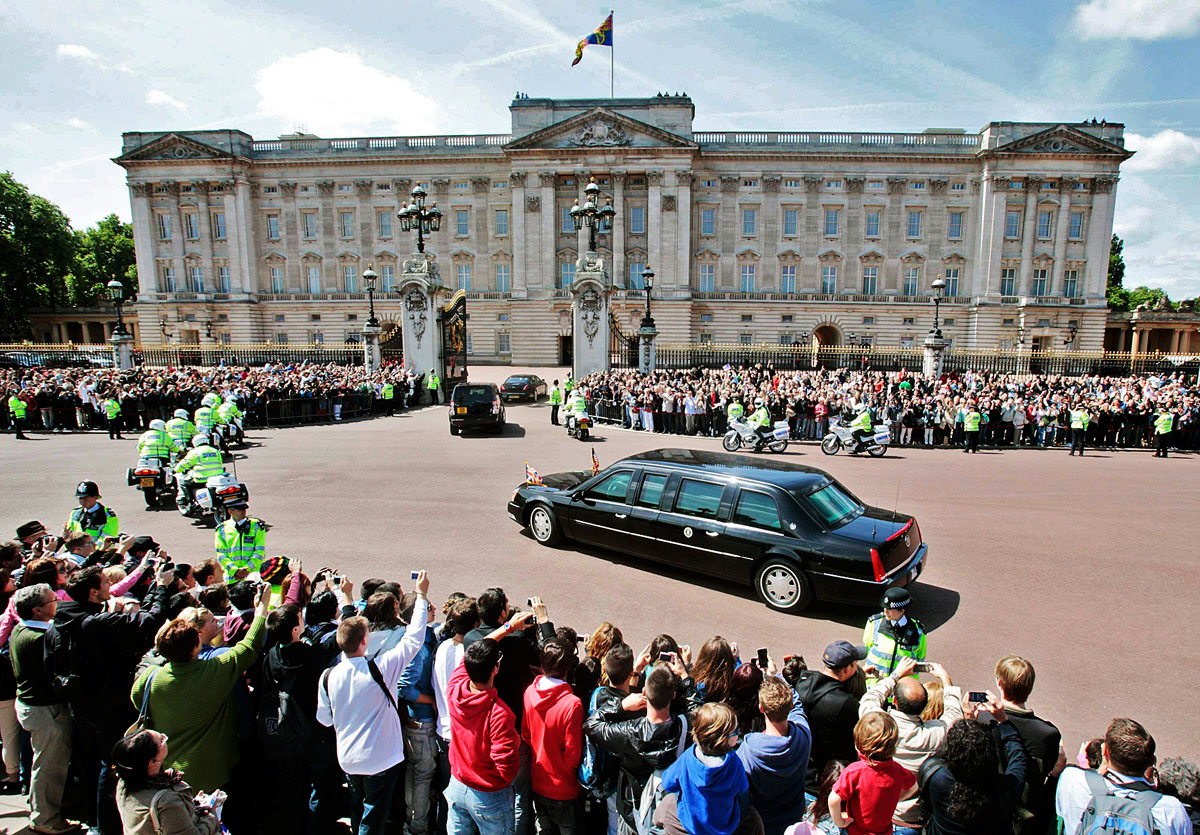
[0,368,1200,758]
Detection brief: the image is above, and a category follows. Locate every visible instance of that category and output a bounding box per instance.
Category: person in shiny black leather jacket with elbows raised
[583,661,688,835]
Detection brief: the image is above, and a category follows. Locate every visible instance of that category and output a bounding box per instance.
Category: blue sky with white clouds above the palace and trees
[0,0,1200,298]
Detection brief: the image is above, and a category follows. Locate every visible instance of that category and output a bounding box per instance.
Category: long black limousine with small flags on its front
[509,449,928,612]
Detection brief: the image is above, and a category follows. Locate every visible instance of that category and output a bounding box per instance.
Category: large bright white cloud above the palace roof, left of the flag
[254,47,438,136]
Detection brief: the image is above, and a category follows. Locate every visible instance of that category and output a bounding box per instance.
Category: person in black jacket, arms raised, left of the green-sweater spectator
[46,565,175,835]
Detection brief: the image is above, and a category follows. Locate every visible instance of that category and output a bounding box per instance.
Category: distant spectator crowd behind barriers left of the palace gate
[0,362,427,432]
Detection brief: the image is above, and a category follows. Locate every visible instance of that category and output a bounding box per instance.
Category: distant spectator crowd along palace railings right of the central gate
[578,365,1200,450]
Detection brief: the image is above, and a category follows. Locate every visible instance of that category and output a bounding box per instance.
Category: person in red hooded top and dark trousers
[521,638,583,835]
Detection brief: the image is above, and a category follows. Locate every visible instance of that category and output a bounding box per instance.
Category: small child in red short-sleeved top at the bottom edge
[829,711,917,835]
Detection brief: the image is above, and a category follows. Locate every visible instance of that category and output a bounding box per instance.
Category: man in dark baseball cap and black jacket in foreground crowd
[796,641,866,797]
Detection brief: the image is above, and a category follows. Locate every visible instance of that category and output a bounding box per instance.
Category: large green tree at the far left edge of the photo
[0,172,76,340]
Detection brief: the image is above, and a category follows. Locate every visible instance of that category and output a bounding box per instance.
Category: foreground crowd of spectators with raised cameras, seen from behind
[0,522,1200,835]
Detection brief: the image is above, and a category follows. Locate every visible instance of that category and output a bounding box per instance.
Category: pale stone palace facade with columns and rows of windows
[115,95,1130,365]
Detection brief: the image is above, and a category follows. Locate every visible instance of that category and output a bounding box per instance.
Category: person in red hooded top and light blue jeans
[445,638,521,835]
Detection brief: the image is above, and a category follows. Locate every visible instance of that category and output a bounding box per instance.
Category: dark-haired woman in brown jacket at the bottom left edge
[108,731,221,835]
